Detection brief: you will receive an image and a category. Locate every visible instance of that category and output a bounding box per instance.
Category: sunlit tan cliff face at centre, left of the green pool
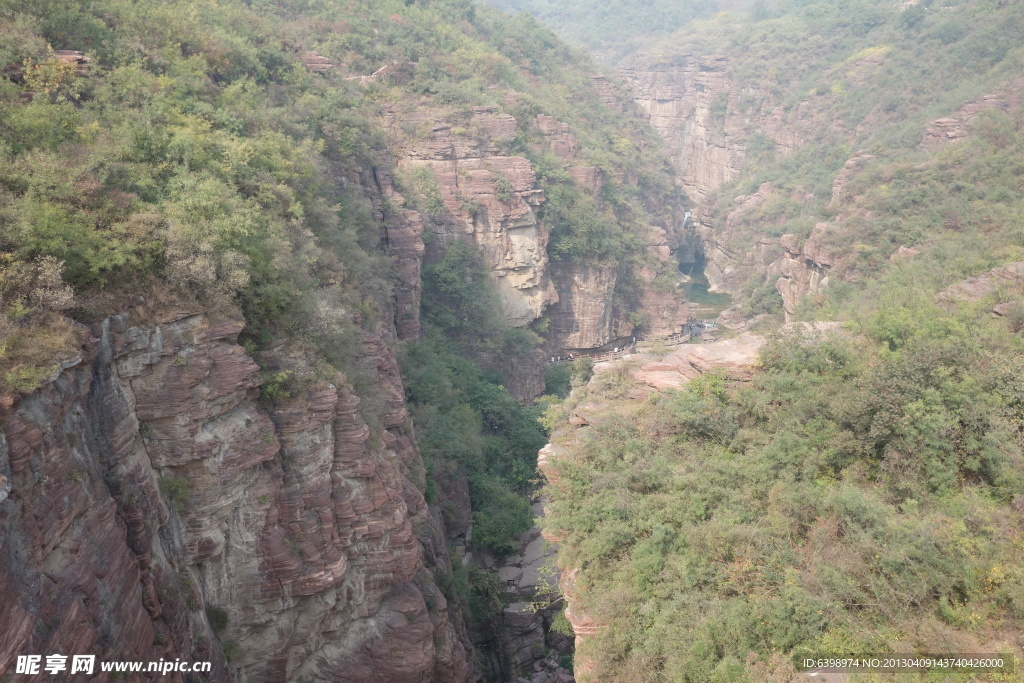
[387,103,686,358]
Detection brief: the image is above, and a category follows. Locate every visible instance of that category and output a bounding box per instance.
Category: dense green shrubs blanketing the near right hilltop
[544,286,1024,680]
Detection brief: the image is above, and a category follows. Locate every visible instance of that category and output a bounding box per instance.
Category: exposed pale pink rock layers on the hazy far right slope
[621,47,1024,319]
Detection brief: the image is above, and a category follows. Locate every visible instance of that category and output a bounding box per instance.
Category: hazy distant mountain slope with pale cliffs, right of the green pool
[623,2,1024,317]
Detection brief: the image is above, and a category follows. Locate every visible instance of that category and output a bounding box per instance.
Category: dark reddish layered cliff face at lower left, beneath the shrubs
[0,313,473,681]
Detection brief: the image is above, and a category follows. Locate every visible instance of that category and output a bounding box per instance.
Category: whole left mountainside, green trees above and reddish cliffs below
[0,0,685,681]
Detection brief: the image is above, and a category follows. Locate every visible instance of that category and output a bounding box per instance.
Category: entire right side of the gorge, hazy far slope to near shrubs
[532,1,1024,681]
